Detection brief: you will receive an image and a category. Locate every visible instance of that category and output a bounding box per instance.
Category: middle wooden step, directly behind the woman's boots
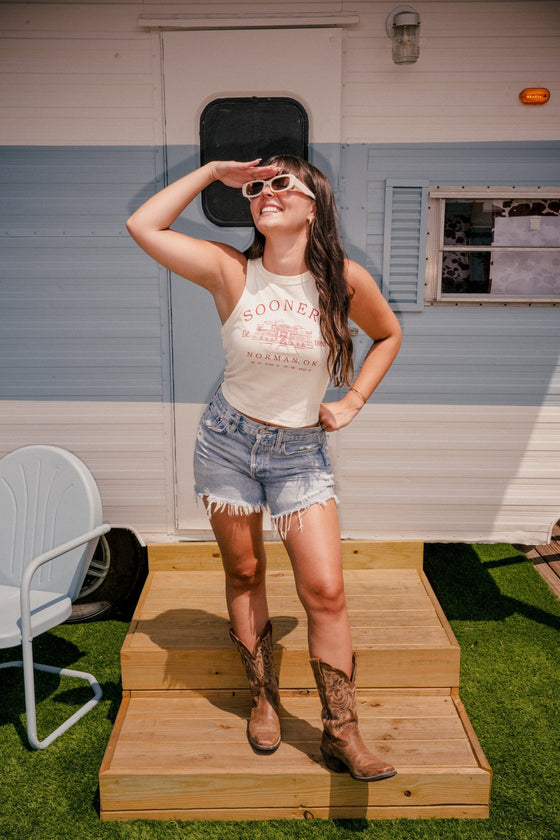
[121,568,460,691]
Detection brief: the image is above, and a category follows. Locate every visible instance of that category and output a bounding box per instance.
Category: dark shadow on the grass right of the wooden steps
[424,543,560,630]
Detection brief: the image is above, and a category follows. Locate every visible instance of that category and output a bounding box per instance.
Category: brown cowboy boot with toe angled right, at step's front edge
[311,654,397,782]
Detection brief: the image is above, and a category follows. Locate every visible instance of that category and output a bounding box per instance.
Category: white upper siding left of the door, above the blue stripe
[0,22,155,146]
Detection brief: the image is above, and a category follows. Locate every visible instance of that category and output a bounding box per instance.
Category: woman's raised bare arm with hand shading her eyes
[127,160,277,296]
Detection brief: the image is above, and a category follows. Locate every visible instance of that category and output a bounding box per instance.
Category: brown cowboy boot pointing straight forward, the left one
[229,621,281,752]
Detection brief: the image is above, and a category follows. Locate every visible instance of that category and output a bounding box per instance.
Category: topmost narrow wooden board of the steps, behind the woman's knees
[148,540,424,571]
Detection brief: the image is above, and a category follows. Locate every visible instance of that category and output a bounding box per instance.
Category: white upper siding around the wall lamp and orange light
[342,0,560,143]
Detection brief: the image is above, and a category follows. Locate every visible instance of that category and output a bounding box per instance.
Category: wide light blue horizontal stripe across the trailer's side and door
[0,142,560,405]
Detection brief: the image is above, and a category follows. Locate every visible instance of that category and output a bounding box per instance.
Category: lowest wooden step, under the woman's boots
[100,689,491,820]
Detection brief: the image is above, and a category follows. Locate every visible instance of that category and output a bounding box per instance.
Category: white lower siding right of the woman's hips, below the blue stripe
[336,403,560,543]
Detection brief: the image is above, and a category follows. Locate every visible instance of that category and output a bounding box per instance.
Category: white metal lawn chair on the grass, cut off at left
[0,446,110,749]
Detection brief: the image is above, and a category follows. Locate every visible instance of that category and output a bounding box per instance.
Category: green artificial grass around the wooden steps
[0,544,560,840]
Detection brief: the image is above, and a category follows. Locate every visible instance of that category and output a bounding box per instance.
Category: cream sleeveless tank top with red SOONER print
[222,259,330,428]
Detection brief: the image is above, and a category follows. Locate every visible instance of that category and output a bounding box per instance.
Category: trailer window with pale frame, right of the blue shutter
[427,188,560,303]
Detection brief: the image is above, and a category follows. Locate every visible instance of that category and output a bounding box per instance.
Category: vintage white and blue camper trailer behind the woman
[0,0,560,612]
